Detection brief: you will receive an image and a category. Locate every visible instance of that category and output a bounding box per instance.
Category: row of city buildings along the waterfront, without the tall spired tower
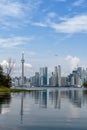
[12,65,87,87]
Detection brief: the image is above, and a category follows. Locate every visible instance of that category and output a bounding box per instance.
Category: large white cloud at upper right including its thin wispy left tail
[33,15,87,34]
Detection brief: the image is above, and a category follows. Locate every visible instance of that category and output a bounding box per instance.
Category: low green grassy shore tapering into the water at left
[0,87,30,92]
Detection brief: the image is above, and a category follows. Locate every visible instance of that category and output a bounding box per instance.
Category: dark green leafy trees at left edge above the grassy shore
[0,65,11,88]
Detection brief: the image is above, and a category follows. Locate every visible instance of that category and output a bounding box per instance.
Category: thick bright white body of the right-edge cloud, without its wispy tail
[49,15,87,33]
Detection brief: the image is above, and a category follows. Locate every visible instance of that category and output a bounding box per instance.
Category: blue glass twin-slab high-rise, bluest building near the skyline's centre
[40,67,47,86]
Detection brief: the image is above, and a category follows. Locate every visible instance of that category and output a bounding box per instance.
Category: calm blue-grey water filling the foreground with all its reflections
[0,89,87,130]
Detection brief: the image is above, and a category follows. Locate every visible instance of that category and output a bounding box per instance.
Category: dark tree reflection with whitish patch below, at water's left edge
[0,93,11,114]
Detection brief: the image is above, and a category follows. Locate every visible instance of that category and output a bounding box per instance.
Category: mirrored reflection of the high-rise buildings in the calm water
[28,90,83,109]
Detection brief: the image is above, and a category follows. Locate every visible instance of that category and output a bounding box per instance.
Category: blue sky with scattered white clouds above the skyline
[0,0,87,76]
